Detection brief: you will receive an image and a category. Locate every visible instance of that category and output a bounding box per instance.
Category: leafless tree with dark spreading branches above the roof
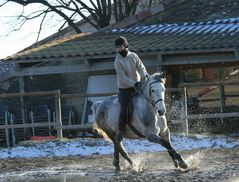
[0,0,142,33]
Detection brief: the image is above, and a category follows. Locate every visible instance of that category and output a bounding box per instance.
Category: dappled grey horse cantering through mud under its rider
[92,73,188,171]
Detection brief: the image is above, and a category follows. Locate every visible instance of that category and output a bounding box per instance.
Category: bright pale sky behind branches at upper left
[0,0,84,59]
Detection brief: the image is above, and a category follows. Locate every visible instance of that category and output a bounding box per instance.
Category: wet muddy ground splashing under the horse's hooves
[0,147,239,182]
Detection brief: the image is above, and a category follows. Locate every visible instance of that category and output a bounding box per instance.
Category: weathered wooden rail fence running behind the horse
[0,79,239,146]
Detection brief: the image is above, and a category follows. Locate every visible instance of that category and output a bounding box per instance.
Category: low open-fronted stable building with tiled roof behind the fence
[0,18,239,136]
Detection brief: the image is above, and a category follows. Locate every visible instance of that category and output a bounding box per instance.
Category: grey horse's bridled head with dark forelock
[142,73,166,116]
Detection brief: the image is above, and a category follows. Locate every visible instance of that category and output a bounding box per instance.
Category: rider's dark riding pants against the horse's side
[118,87,135,132]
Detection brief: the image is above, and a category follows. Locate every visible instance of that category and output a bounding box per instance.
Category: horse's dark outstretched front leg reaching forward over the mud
[147,134,188,169]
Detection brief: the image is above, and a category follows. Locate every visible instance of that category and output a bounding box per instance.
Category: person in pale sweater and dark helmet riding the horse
[115,36,149,141]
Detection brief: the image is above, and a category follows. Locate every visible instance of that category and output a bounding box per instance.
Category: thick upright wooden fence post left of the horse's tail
[55,90,63,138]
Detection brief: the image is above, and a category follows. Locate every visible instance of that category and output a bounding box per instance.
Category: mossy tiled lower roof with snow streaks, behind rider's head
[2,18,239,60]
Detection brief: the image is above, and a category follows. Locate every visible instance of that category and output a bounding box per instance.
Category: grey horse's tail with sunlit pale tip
[92,101,110,140]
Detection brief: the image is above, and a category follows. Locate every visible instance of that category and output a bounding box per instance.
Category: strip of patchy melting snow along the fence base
[0,135,239,159]
